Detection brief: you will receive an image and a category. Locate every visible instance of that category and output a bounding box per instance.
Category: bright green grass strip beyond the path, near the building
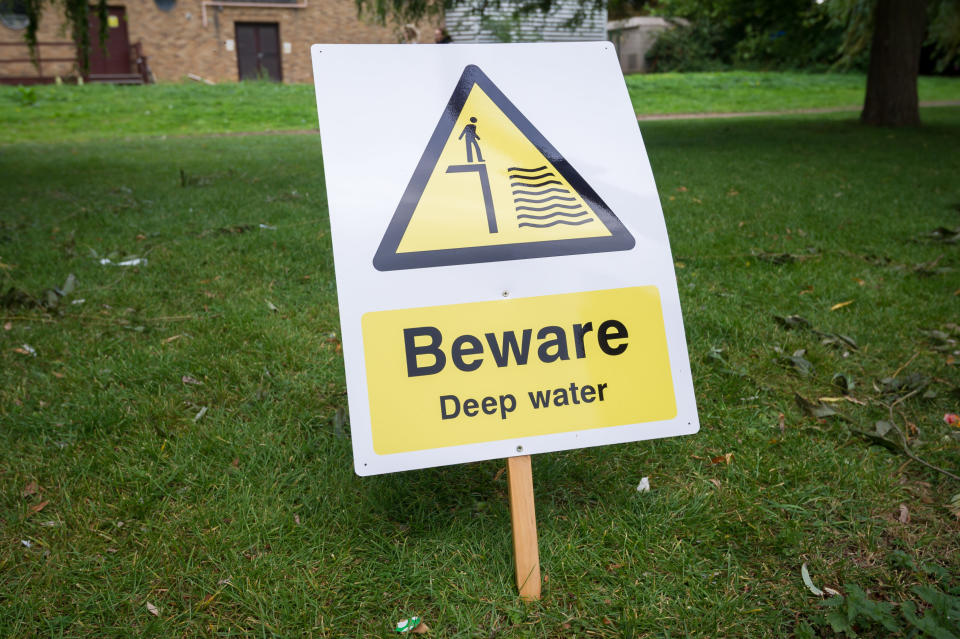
[0,71,960,145]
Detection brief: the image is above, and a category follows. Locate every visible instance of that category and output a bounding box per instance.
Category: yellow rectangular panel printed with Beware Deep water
[362,286,677,455]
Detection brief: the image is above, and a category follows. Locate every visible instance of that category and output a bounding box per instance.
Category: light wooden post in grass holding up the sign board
[507,455,540,601]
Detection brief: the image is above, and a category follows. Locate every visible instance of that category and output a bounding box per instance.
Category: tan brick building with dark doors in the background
[0,0,433,83]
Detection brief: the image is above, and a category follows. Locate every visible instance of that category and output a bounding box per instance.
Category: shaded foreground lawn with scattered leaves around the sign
[0,88,960,637]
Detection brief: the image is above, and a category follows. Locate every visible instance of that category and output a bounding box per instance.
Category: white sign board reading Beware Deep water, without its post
[313,42,699,475]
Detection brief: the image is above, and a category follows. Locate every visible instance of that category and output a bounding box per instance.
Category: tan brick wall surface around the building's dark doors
[0,0,433,82]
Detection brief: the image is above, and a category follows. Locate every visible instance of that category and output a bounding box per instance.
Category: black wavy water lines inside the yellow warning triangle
[507,166,594,229]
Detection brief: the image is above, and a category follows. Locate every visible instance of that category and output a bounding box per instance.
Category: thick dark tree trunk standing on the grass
[860,0,927,126]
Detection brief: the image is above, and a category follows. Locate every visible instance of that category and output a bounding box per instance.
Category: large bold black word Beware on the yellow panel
[403,319,628,377]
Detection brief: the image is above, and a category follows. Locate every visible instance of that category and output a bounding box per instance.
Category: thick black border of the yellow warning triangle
[373,64,636,271]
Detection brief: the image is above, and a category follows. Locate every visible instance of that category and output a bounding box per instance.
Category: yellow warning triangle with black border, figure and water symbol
[373,65,634,271]
